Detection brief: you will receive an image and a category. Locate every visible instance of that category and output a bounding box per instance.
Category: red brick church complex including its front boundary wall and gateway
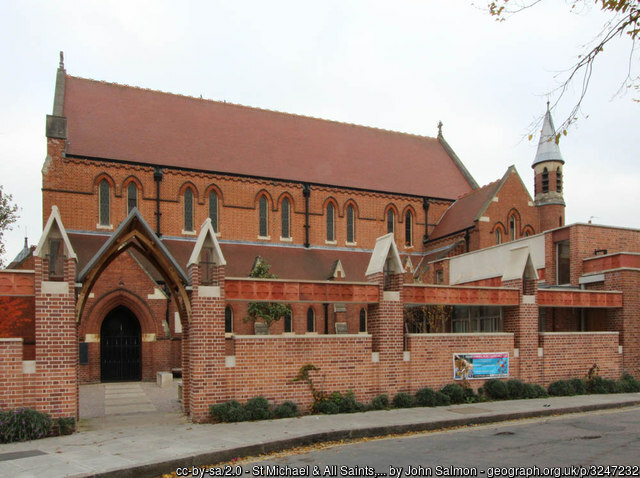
[0,56,640,420]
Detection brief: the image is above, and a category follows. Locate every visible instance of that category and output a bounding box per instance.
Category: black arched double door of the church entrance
[100,305,142,382]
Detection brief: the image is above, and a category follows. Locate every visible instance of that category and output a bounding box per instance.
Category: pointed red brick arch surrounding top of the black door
[84,289,158,334]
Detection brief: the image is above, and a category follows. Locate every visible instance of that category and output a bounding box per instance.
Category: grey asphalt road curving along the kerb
[227,408,640,478]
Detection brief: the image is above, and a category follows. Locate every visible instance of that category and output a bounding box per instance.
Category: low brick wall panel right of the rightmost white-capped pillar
[540,332,622,386]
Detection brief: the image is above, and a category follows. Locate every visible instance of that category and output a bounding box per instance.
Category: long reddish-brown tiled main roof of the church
[64,76,472,199]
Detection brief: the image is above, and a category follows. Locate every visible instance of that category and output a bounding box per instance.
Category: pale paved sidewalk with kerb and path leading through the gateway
[0,383,640,477]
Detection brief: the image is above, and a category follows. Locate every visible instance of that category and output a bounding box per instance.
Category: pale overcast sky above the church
[0,0,640,260]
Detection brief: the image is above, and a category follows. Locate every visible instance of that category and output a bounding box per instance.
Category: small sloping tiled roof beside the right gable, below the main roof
[429,180,502,241]
